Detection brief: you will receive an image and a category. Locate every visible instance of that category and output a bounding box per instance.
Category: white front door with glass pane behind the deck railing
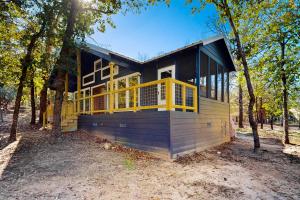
[157,65,175,110]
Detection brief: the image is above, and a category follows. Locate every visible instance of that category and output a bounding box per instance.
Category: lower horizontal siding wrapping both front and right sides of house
[78,101,230,158]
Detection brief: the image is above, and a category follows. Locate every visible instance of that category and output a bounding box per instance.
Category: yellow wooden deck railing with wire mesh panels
[74,78,198,114]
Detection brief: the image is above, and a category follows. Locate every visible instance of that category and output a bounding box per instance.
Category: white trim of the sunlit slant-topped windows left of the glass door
[107,72,141,109]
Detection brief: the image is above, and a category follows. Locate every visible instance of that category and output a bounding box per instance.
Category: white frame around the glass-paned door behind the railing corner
[157,65,176,111]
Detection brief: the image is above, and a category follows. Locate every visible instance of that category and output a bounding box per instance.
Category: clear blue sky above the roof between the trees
[87,0,217,60]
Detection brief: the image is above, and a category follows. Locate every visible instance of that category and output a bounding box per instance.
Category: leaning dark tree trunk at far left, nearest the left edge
[8,22,45,142]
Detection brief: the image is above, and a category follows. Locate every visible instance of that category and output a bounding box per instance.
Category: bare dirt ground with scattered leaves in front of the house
[0,111,300,200]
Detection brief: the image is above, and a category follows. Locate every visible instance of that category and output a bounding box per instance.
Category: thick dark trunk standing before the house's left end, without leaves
[52,0,78,137]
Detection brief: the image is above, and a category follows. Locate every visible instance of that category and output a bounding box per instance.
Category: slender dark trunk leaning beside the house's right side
[224,1,260,151]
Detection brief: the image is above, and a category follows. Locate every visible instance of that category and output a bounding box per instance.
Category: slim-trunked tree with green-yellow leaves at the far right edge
[255,1,300,144]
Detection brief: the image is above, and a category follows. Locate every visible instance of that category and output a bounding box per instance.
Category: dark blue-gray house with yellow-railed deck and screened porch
[49,37,235,158]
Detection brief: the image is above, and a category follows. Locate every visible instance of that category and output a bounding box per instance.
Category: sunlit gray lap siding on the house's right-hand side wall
[170,98,230,157]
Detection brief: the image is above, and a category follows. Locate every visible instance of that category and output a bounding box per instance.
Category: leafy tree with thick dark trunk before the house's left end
[52,0,142,137]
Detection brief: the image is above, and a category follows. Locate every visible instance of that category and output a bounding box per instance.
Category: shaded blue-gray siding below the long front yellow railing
[78,111,170,154]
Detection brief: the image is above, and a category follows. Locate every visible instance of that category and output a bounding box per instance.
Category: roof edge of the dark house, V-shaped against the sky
[83,36,235,71]
